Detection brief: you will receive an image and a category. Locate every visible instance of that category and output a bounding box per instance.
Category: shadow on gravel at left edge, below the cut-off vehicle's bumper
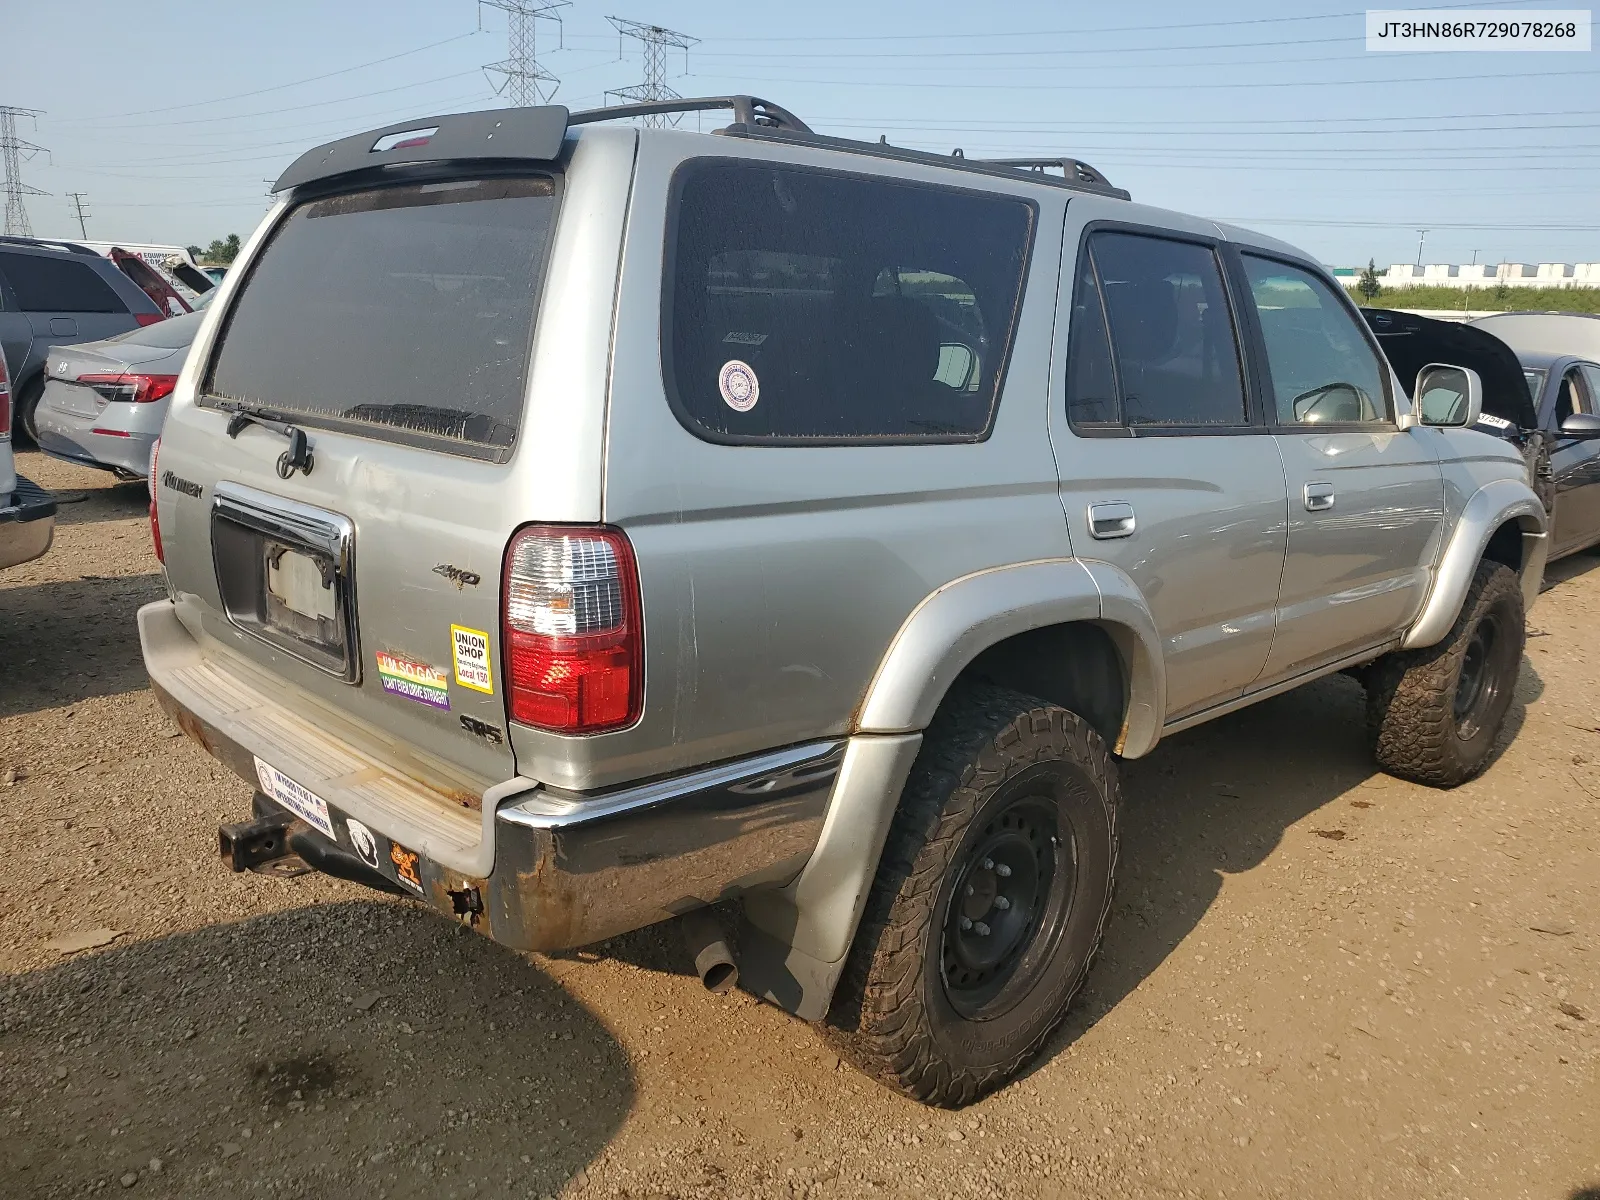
[0,571,165,717]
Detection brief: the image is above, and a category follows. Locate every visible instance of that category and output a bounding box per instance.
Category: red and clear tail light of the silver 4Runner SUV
[501,525,645,733]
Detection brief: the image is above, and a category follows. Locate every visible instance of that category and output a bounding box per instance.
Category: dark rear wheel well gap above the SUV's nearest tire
[958,621,1128,746]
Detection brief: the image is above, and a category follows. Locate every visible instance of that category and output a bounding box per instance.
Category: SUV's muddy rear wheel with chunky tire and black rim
[824,685,1122,1107]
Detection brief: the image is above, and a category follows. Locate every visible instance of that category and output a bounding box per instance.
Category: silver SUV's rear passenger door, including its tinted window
[1051,214,1285,720]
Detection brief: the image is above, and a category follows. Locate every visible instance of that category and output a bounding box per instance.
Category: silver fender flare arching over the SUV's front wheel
[1402,478,1550,650]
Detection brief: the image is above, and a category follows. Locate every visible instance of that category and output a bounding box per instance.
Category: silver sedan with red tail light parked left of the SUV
[34,305,204,480]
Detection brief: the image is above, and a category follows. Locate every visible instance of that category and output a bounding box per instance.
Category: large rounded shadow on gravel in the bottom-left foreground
[0,901,635,1200]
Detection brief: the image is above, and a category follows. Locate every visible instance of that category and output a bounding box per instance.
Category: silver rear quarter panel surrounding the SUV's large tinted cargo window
[514,134,1070,787]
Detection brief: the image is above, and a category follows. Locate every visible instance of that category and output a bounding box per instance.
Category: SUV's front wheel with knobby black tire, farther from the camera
[1366,560,1526,787]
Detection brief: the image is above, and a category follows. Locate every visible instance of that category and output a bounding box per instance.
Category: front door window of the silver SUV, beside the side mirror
[1243,254,1389,426]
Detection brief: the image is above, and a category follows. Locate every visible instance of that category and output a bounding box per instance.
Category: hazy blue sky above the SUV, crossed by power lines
[0,0,1600,266]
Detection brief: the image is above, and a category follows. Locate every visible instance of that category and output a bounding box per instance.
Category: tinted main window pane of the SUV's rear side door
[1088,232,1248,429]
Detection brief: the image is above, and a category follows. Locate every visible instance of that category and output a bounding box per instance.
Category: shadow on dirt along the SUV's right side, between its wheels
[1038,658,1544,1064]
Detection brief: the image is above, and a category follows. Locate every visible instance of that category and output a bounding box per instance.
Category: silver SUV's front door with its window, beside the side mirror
[1238,251,1445,686]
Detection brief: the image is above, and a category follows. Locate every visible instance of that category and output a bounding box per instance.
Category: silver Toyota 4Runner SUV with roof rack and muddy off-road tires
[139,98,1546,1106]
